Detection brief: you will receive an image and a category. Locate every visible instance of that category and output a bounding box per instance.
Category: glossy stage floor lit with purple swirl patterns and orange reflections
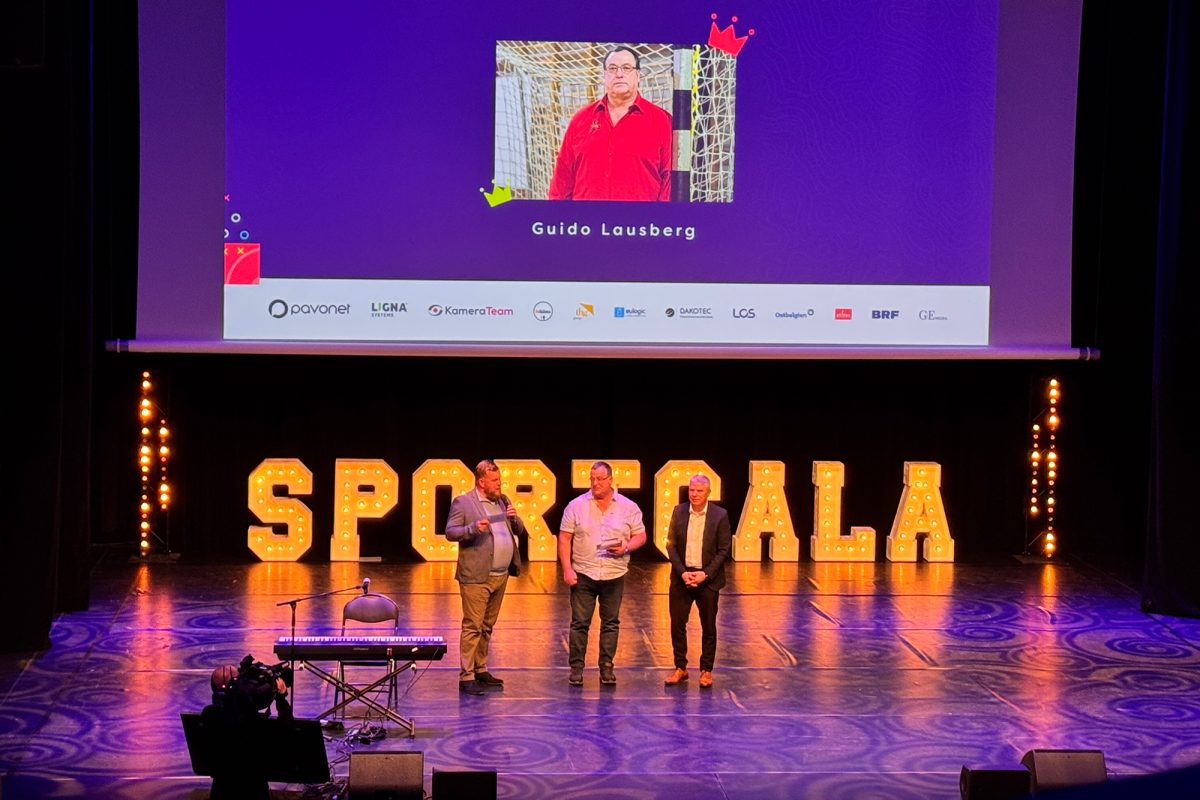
[0,559,1200,800]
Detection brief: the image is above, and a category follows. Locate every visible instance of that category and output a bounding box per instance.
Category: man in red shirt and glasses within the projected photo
[548,46,671,200]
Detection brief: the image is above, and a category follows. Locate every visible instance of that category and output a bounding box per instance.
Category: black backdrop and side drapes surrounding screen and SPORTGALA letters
[0,0,1200,649]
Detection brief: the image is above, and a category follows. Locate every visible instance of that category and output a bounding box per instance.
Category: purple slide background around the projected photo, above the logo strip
[225,0,998,284]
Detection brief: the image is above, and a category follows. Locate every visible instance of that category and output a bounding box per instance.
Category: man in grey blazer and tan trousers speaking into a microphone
[445,459,524,694]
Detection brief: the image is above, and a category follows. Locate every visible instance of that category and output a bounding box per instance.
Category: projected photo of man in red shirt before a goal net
[493,41,736,203]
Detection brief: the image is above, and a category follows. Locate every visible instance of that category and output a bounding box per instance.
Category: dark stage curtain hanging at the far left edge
[0,0,109,651]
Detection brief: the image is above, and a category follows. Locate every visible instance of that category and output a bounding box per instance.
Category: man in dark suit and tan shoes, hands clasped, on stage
[664,475,732,688]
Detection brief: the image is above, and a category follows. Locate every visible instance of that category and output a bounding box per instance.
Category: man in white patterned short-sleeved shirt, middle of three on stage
[558,461,646,686]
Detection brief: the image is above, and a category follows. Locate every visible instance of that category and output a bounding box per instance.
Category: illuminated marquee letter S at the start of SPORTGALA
[246,458,312,561]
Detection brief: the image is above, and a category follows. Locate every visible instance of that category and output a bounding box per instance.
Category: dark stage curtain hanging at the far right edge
[1142,0,1200,616]
